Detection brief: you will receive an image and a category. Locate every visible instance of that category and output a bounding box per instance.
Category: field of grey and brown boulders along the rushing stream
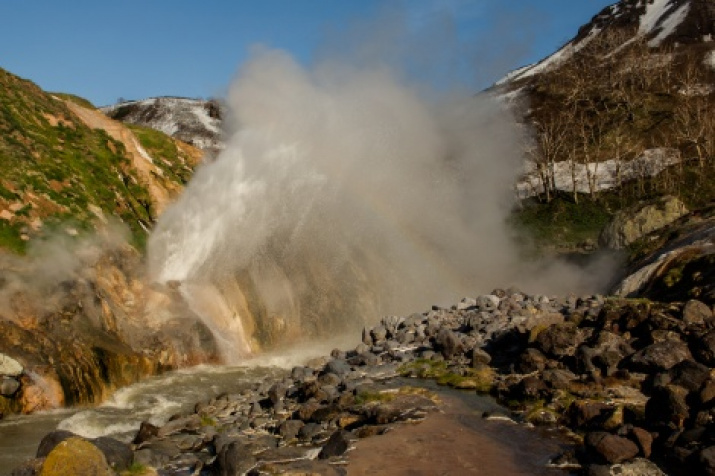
[13,289,715,475]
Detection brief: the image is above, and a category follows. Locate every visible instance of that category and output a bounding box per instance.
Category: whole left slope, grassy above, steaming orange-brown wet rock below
[0,69,218,418]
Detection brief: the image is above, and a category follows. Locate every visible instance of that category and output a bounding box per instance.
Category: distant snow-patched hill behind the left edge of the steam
[100,97,224,158]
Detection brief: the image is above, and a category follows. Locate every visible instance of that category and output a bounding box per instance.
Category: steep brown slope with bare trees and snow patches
[504,0,715,250]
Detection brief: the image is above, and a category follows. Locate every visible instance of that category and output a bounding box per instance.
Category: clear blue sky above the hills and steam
[0,0,615,105]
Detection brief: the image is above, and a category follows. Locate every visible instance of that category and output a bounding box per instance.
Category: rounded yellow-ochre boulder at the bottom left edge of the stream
[40,437,114,476]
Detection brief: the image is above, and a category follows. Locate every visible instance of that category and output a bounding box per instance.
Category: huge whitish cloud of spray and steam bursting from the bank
[149,51,521,355]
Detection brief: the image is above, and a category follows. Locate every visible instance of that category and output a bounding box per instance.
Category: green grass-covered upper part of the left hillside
[0,69,199,253]
